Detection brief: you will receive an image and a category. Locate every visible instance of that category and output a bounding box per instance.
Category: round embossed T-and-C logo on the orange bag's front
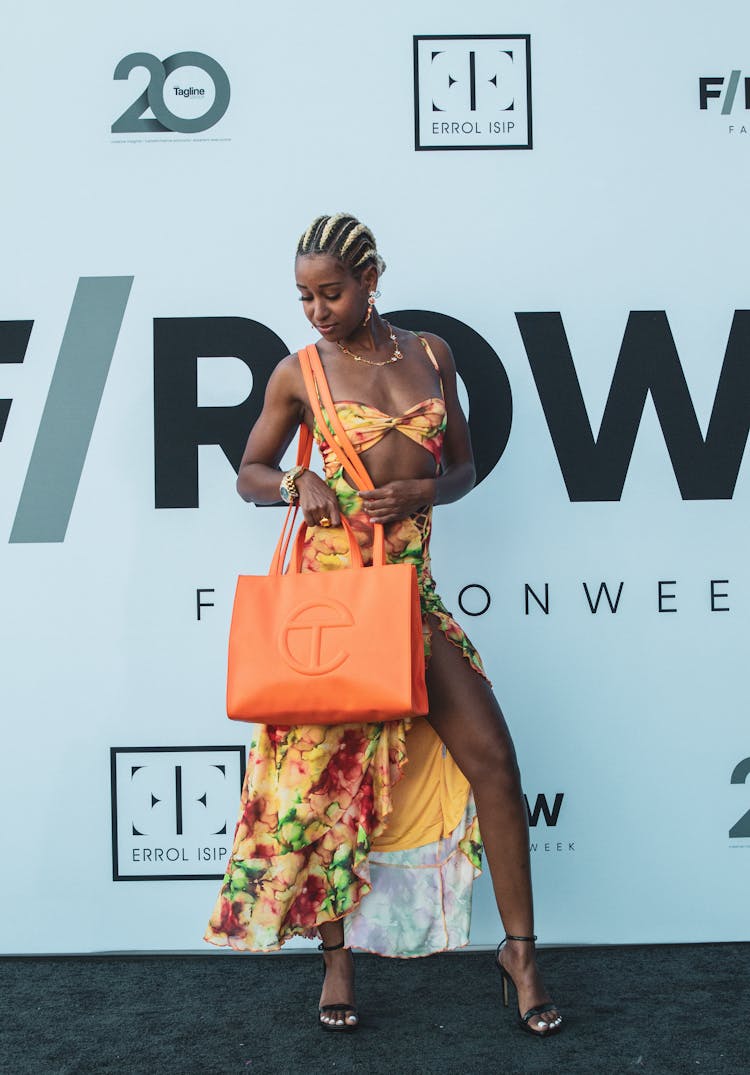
[279,599,355,675]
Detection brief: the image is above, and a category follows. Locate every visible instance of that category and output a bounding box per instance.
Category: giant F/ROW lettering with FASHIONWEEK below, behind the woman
[0,298,750,541]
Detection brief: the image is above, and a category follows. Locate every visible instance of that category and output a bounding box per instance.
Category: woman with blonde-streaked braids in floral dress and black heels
[206,213,562,1036]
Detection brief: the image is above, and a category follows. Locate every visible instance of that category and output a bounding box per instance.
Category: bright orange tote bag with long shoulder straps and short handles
[227,347,428,726]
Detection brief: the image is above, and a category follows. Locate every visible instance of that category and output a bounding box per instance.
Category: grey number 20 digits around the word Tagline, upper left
[112,52,230,134]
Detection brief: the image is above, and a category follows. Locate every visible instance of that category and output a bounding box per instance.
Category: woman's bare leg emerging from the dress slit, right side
[427,618,559,1030]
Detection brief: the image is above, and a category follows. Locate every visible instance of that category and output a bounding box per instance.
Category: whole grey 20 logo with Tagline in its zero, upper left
[112,52,231,134]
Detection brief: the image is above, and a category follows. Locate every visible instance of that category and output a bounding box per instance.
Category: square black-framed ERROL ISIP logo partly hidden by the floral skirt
[110,746,245,880]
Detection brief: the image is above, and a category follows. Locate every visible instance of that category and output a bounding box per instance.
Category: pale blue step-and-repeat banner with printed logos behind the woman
[0,0,750,952]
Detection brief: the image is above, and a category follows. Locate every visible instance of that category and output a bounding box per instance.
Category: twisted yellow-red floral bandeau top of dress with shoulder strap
[313,335,447,477]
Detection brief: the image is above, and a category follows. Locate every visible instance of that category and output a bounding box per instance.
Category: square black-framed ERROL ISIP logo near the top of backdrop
[414,33,532,149]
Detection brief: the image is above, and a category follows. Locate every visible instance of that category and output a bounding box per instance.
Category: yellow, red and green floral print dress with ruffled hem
[205,338,485,957]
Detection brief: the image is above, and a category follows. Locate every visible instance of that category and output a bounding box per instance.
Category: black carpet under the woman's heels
[0,944,750,1075]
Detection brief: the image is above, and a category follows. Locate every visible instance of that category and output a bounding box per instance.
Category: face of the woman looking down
[294,254,373,340]
